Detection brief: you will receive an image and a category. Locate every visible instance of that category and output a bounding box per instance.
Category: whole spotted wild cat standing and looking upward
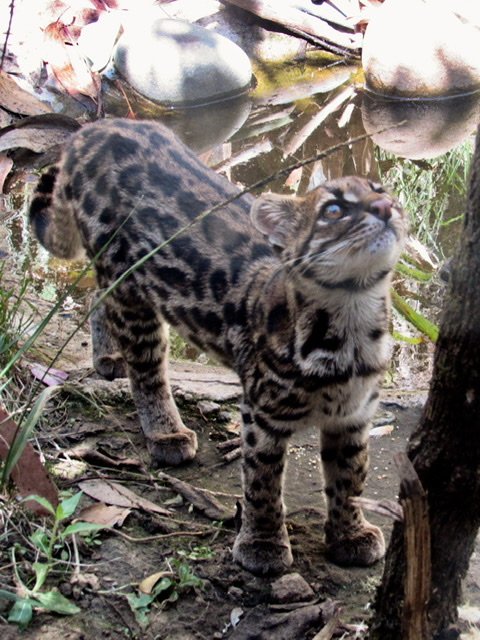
[30,120,406,574]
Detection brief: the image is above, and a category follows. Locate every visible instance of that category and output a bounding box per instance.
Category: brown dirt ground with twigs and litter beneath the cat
[0,356,480,640]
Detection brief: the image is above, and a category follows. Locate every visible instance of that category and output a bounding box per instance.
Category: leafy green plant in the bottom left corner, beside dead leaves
[0,491,104,627]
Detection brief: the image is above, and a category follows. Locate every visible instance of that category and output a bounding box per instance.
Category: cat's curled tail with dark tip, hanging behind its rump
[29,167,84,259]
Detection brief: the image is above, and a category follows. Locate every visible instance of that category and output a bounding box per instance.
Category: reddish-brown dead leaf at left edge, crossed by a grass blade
[0,408,58,515]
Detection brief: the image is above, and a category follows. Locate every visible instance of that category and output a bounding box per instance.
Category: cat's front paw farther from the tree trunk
[233,527,293,576]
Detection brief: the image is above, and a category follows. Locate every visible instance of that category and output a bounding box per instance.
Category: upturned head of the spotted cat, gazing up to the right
[251,176,407,285]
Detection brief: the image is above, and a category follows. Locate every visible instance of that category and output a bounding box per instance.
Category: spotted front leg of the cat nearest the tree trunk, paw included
[321,424,385,566]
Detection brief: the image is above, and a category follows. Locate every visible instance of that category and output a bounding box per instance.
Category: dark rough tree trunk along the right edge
[370,129,480,640]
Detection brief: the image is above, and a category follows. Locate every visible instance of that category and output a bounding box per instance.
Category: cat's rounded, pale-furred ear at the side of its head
[250,193,298,249]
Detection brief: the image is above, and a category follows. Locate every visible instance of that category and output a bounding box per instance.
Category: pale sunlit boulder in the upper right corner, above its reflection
[362,0,480,98]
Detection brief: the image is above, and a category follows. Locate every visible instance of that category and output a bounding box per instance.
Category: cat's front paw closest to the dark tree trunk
[326,523,385,567]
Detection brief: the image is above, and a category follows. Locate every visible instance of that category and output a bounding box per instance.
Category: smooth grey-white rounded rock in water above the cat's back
[114,9,252,106]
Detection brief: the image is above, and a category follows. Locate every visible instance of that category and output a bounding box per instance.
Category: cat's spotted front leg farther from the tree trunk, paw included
[233,405,293,575]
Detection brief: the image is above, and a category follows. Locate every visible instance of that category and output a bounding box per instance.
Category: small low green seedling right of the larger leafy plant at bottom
[127,558,204,629]
